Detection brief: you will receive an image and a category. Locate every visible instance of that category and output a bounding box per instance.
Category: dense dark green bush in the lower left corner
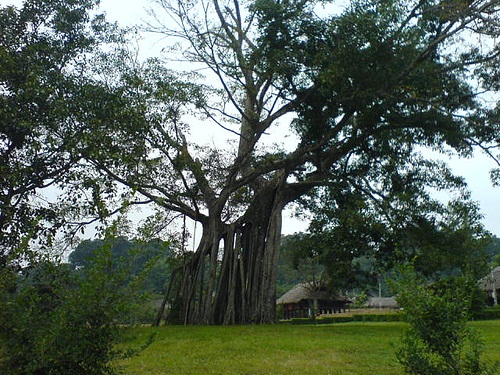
[0,242,141,375]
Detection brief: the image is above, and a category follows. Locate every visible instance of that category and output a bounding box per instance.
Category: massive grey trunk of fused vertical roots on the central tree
[170,185,284,324]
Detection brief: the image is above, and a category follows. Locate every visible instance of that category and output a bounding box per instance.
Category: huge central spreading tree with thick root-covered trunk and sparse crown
[2,0,500,324]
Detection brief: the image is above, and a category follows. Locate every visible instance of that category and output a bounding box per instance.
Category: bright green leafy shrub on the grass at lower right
[397,272,498,375]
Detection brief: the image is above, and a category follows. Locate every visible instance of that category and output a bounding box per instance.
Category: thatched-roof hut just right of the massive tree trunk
[276,282,349,319]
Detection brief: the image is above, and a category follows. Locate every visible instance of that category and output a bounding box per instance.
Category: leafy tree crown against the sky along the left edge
[0,0,118,267]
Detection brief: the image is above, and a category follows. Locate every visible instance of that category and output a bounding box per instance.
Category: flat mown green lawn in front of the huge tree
[119,320,500,375]
